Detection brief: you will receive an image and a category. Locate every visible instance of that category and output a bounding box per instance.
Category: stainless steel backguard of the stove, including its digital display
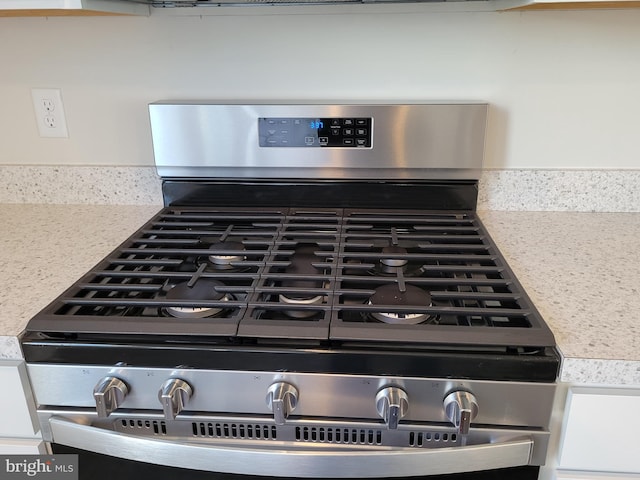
[149,102,488,182]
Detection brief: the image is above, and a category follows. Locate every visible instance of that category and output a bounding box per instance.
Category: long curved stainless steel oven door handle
[49,417,533,478]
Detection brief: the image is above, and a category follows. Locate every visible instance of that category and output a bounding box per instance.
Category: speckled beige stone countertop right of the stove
[480,211,640,385]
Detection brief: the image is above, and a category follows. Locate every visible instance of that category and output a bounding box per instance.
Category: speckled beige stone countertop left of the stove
[0,204,162,359]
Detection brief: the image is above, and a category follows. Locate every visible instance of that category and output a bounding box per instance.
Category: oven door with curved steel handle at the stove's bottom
[49,417,538,480]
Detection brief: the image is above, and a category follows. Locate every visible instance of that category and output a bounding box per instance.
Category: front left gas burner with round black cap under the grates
[164,278,233,318]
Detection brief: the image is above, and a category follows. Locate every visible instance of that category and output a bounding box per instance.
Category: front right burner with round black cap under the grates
[369,284,431,325]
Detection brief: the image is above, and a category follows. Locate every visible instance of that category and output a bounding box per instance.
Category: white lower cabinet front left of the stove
[0,360,44,454]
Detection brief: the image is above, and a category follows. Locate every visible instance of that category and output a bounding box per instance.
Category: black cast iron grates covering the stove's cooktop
[29,207,554,347]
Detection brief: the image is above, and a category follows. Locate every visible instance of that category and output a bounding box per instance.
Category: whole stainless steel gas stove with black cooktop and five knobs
[22,102,559,479]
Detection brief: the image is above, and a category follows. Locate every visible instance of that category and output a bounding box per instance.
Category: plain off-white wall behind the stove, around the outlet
[0,6,640,169]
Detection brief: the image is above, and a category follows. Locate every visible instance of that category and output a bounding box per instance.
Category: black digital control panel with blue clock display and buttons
[258,117,373,148]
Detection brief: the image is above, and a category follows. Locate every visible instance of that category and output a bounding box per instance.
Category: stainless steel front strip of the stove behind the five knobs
[29,364,555,428]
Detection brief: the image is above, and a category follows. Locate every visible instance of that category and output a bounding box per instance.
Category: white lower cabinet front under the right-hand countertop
[557,386,640,480]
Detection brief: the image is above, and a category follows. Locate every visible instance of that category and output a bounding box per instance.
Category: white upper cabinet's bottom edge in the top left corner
[0,0,149,17]
